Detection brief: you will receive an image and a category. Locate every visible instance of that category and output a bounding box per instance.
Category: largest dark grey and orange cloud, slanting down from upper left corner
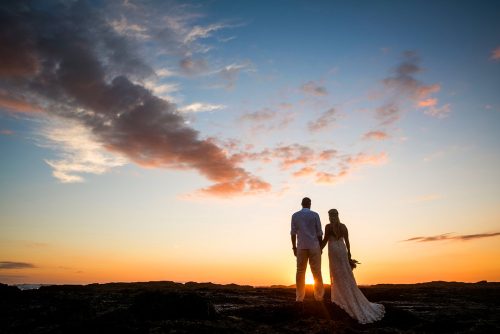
[0,1,270,196]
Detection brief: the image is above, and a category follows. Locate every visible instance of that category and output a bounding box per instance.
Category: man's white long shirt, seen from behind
[290,208,323,249]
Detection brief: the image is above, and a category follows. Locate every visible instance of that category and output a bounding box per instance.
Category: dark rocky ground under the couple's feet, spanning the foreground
[0,282,500,333]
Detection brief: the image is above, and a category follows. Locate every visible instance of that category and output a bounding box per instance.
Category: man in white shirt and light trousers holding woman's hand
[290,197,324,302]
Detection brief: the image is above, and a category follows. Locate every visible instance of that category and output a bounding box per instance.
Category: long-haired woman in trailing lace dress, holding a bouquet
[321,209,385,324]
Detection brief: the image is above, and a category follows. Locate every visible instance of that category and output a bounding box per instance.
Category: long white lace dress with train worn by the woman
[328,236,385,324]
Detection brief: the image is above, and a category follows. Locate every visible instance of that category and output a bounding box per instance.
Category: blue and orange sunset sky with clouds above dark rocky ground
[0,0,500,285]
